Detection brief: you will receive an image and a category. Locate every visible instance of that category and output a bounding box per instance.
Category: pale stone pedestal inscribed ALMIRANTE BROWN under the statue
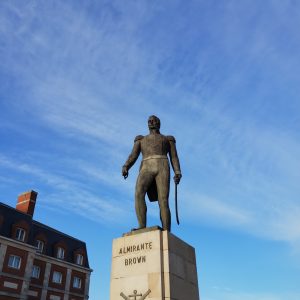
[110,227,199,300]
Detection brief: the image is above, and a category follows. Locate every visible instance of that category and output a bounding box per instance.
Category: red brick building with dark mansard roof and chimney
[0,191,92,300]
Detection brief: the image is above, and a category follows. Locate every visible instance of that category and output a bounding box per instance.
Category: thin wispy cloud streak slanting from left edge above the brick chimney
[0,155,127,223]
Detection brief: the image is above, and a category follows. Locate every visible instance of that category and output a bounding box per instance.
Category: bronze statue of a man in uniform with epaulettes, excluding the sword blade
[122,116,181,231]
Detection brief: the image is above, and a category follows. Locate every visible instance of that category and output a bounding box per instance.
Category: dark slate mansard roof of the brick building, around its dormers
[0,202,89,268]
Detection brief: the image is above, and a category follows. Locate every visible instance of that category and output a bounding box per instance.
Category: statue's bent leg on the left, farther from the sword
[135,170,154,228]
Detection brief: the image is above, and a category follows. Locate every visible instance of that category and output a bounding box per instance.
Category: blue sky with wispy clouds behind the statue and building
[0,0,300,300]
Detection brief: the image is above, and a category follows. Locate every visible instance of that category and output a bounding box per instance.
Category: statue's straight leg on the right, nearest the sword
[155,159,171,231]
